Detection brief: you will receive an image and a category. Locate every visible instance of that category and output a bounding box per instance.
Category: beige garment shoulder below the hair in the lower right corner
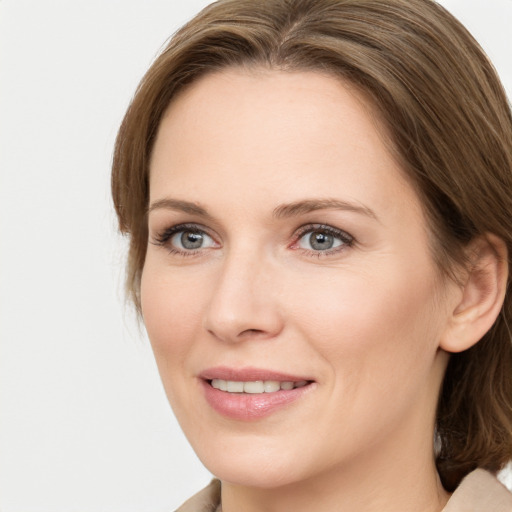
[443,469,512,512]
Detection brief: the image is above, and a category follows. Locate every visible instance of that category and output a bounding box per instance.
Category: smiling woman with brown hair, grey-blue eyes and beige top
[113,0,512,512]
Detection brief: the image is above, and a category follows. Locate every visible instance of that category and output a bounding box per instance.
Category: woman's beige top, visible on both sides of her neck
[176,469,512,512]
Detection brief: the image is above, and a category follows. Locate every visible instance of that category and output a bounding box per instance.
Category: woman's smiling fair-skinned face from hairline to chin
[142,70,454,487]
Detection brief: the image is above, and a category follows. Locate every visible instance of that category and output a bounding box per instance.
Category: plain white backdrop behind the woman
[0,0,512,512]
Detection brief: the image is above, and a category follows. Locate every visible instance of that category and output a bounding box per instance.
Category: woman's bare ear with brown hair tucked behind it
[440,233,508,352]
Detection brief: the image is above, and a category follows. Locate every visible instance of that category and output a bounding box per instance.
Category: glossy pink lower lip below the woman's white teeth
[201,380,314,421]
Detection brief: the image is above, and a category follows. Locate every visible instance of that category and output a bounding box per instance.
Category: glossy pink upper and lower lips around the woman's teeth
[199,367,316,421]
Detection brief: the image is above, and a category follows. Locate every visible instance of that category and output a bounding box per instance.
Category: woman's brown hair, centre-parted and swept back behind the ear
[112,0,512,490]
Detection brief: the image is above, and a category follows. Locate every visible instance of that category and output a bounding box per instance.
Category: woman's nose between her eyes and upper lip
[204,252,283,343]
